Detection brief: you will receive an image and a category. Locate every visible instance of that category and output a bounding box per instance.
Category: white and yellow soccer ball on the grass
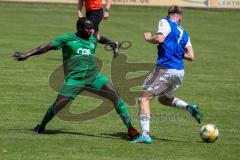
[200,124,219,143]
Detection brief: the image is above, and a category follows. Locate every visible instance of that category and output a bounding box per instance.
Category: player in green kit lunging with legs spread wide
[14,17,138,139]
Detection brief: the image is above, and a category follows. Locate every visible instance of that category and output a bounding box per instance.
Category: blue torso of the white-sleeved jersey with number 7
[157,18,189,70]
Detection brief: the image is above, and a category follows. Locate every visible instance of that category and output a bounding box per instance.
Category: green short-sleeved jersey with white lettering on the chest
[50,33,99,80]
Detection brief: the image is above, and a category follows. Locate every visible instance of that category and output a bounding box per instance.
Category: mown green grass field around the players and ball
[0,2,240,160]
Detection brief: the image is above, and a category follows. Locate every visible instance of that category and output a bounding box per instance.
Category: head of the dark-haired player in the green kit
[77,17,94,38]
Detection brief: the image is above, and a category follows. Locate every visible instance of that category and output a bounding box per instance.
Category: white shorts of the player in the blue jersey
[143,67,184,98]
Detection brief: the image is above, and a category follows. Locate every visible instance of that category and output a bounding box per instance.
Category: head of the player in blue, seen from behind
[168,5,183,23]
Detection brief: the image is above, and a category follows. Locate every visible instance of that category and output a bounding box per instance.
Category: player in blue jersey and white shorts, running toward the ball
[132,5,202,144]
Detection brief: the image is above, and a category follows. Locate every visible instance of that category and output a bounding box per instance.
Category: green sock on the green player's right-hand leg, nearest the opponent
[115,98,132,128]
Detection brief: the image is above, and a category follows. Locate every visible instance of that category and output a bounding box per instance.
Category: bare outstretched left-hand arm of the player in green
[13,43,55,61]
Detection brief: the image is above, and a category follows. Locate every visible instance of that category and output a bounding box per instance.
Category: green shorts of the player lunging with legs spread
[58,73,109,100]
